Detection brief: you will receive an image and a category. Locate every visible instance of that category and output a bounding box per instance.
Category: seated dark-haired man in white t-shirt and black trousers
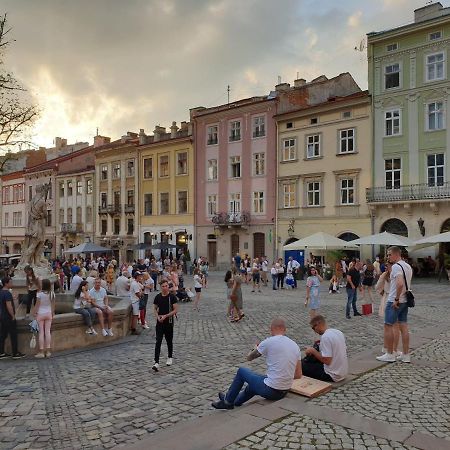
[302,315,348,381]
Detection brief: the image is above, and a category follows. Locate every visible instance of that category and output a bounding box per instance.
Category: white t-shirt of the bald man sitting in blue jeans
[257,335,301,391]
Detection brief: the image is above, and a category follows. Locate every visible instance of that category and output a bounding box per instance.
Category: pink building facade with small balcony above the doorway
[191,96,276,269]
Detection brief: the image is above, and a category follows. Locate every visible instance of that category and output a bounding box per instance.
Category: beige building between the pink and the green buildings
[277,79,372,260]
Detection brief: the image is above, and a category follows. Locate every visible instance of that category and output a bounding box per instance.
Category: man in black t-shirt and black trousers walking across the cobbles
[152,280,178,372]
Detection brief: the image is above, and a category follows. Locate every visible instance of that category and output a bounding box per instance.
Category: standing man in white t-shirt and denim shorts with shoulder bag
[377,247,412,363]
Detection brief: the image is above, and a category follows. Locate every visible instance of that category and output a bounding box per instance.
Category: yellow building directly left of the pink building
[138,122,195,256]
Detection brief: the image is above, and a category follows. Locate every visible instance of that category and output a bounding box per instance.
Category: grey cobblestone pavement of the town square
[0,274,450,450]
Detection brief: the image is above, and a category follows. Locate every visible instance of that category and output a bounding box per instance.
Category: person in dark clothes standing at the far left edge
[0,277,25,359]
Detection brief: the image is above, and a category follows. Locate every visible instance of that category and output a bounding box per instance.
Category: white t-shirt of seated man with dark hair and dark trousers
[319,328,348,381]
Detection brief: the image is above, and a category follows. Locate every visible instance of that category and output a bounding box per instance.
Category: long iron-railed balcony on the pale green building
[366,182,450,203]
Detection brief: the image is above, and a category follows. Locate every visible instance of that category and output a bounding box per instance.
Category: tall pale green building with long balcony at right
[367,3,450,254]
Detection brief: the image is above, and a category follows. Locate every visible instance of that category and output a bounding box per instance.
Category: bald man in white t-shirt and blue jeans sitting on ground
[212,319,302,409]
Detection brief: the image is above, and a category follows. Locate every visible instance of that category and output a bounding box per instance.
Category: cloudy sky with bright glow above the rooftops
[0,0,438,147]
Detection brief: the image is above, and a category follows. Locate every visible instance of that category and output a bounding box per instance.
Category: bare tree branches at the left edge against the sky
[0,14,39,168]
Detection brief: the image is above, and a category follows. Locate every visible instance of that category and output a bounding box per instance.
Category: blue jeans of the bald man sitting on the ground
[225,367,287,406]
